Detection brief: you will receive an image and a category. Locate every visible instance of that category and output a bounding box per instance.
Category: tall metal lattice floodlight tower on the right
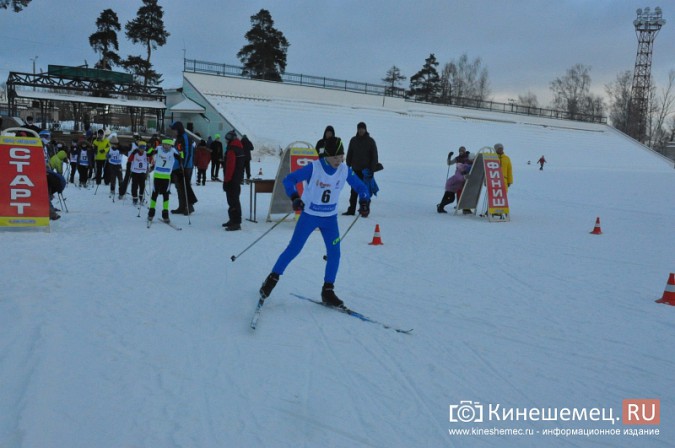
[629,6,666,142]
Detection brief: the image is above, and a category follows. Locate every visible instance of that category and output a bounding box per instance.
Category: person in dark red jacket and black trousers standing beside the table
[223,131,246,231]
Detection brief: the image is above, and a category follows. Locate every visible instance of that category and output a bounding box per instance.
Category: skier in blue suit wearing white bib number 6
[260,137,370,307]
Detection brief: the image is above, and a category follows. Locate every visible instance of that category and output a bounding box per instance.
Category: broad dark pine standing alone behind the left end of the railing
[237,9,290,81]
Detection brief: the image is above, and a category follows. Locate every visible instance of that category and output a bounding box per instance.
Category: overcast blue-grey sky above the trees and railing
[0,0,675,106]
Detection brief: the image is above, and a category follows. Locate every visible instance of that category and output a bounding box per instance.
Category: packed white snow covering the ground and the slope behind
[0,79,675,448]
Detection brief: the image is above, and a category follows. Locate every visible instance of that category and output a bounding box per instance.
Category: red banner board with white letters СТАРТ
[0,135,49,230]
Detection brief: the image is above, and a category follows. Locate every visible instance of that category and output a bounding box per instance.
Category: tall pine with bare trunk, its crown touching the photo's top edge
[124,0,170,86]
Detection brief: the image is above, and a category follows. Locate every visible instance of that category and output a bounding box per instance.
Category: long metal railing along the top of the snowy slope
[183,59,607,124]
